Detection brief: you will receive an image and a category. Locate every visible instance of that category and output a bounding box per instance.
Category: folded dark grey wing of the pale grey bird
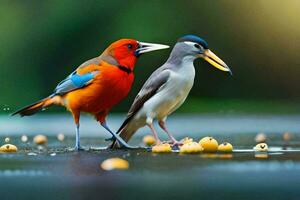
[117,68,170,133]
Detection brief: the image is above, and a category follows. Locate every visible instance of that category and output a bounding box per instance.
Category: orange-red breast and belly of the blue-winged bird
[64,65,134,114]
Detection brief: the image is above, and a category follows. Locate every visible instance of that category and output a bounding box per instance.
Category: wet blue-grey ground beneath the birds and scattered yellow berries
[0,116,300,199]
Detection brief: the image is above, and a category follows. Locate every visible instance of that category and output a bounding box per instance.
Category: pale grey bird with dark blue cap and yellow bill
[110,35,232,148]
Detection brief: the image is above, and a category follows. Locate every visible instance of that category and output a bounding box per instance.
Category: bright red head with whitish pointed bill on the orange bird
[105,39,169,70]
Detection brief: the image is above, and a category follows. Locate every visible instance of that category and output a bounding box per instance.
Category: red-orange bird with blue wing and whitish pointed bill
[12,39,169,150]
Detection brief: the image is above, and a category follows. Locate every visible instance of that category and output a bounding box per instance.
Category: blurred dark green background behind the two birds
[0,0,300,114]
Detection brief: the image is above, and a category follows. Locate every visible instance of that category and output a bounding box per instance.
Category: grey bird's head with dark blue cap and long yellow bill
[172,35,232,74]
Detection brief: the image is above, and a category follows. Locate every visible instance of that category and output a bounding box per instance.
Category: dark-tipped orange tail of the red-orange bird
[12,95,55,117]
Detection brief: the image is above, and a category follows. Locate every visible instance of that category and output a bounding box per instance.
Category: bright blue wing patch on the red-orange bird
[54,71,99,95]
